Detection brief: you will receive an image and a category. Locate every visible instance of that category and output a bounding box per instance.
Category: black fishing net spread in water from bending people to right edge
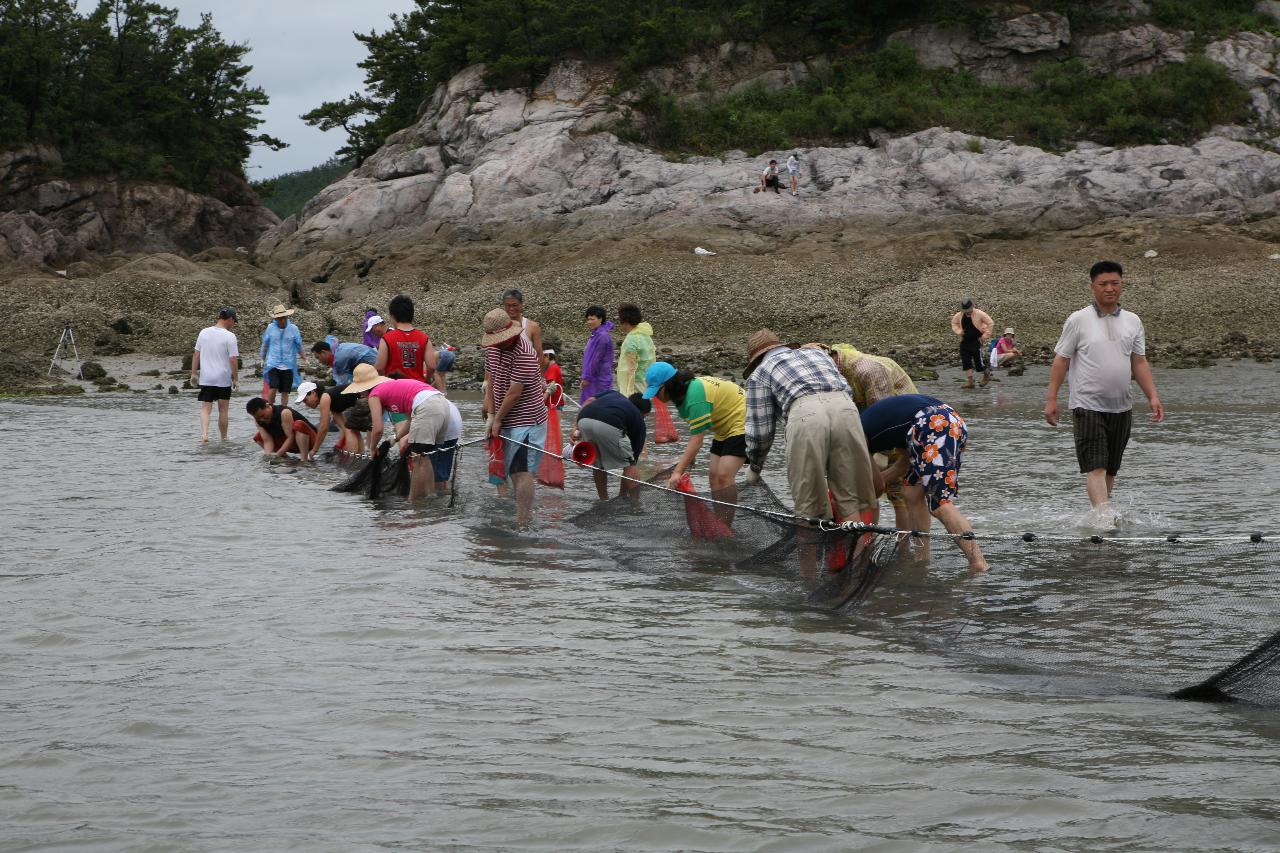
[572,471,1280,707]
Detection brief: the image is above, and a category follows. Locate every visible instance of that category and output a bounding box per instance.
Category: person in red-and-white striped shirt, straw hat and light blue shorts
[480,309,547,525]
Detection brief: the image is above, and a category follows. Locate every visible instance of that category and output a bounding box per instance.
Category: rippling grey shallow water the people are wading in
[0,365,1280,850]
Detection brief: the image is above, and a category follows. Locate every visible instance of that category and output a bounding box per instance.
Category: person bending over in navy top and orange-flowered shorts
[859,394,988,571]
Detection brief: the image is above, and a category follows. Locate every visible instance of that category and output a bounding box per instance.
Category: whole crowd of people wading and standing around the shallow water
[192,261,1164,571]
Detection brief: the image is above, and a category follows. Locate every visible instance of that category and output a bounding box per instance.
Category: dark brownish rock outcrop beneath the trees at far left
[0,146,279,264]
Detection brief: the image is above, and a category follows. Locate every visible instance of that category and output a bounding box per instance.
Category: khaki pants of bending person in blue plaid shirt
[787,391,878,520]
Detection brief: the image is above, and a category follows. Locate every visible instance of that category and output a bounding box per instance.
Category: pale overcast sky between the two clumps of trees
[167,0,413,181]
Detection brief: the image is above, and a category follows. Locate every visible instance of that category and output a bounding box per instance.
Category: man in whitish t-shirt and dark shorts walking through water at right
[1044,261,1165,512]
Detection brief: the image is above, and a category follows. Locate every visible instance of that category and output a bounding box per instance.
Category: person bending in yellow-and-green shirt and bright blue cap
[643,361,746,503]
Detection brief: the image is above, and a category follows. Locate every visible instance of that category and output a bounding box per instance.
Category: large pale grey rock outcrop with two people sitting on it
[257,46,1280,280]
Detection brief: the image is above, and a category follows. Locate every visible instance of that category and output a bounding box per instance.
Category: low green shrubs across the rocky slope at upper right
[618,45,1249,155]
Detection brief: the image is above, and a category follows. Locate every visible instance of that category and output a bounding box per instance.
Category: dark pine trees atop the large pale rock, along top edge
[302,0,947,159]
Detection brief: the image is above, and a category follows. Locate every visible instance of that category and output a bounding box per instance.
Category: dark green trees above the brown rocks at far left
[0,0,283,191]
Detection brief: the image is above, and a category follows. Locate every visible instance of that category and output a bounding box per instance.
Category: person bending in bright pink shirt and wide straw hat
[343,364,462,500]
